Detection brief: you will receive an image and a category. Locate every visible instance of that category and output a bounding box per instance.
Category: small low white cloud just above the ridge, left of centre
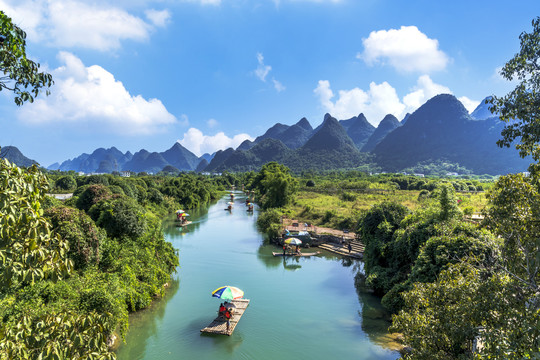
[178,128,254,156]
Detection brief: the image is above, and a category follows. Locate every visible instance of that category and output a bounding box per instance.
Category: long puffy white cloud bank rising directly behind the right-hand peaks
[313,75,480,126]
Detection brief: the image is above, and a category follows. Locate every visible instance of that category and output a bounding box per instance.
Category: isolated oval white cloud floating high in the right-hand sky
[356,26,449,74]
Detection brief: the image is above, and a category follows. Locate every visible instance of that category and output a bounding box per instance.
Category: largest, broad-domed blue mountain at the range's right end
[373,94,529,174]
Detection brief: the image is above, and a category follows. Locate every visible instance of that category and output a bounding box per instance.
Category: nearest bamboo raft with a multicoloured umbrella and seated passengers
[201,285,249,336]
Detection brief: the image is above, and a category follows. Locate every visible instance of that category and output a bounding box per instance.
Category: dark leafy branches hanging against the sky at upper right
[487,17,540,174]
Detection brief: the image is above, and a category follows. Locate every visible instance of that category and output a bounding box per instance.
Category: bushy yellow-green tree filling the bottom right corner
[390,263,540,359]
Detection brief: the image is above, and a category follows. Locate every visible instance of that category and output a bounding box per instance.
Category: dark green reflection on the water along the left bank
[119,279,180,359]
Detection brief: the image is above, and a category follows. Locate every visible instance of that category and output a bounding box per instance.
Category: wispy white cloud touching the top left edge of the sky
[0,0,170,51]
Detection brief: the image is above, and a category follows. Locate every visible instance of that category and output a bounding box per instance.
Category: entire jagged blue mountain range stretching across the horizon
[2,94,530,175]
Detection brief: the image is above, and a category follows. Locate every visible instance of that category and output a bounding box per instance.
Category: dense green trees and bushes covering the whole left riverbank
[0,159,247,359]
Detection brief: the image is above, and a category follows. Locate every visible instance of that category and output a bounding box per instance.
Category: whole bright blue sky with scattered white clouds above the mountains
[0,0,540,166]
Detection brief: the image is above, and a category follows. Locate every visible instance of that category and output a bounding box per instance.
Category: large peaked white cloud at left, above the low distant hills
[17,52,175,135]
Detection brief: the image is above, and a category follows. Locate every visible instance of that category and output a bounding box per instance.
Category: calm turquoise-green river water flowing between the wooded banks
[117,193,399,360]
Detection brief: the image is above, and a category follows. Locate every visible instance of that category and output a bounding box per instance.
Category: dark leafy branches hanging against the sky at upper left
[0,11,54,106]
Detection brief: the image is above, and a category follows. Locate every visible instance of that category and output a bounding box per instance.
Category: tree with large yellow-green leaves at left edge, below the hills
[0,159,72,288]
